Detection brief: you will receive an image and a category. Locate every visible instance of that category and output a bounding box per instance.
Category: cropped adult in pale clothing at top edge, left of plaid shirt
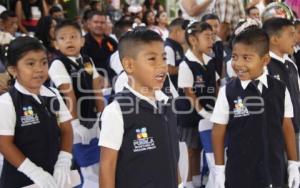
[179,0,216,21]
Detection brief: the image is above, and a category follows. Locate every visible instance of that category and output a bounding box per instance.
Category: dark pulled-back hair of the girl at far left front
[5,36,47,67]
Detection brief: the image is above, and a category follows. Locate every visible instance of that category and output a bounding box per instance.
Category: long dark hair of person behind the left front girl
[35,16,53,49]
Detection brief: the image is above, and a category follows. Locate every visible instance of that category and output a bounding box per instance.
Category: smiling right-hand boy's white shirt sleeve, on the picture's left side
[210,86,230,125]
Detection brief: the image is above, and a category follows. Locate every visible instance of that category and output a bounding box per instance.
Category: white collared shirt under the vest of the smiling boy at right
[210,72,294,125]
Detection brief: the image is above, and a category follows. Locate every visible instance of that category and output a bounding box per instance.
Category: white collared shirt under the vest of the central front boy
[99,84,169,151]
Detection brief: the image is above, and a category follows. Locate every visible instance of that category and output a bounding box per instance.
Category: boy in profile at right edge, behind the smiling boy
[263,18,300,157]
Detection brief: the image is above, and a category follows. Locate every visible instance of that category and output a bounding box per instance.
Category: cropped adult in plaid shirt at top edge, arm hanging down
[215,0,245,41]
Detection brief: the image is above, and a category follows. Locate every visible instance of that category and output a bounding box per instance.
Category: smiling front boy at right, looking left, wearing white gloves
[211,28,299,188]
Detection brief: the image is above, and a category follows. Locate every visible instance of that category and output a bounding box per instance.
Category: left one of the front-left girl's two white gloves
[18,158,57,188]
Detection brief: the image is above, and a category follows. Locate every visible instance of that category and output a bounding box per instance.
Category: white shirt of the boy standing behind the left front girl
[48,56,99,87]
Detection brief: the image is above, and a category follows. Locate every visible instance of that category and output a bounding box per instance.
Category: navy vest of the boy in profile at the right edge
[267,58,300,133]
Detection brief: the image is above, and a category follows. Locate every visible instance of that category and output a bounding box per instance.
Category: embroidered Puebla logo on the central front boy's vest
[133,127,156,152]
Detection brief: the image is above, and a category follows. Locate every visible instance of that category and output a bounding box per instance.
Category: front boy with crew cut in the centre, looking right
[99,28,179,188]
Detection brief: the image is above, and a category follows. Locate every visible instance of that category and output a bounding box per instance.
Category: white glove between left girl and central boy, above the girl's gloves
[71,119,91,145]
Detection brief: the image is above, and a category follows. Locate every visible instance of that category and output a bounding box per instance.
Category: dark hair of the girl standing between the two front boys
[185,22,212,47]
